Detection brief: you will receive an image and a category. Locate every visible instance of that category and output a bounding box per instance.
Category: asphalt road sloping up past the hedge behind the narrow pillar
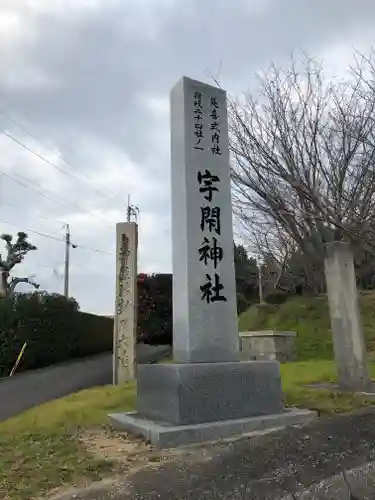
[0,345,168,421]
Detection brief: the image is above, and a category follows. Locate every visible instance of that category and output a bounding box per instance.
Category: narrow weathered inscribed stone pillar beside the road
[113,222,138,385]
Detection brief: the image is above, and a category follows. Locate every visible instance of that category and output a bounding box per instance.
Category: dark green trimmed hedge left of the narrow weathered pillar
[0,293,113,377]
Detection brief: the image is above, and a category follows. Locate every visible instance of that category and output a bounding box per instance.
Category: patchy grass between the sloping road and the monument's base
[0,384,135,500]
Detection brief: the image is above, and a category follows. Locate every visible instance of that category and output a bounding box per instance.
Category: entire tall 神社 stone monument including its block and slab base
[110,77,313,447]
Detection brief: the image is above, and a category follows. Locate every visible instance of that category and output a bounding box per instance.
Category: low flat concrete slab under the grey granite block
[109,408,316,449]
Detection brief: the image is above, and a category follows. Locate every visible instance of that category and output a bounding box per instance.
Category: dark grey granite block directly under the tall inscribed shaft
[137,361,283,424]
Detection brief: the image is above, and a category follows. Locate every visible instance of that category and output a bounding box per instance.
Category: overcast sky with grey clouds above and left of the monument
[0,0,375,314]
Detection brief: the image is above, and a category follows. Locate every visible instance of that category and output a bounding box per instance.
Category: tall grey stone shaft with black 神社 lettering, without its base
[171,77,239,363]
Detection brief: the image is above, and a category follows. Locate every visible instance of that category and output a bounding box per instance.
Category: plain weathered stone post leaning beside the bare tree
[325,241,371,391]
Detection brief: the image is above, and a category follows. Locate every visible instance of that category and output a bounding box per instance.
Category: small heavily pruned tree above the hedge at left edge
[0,232,39,297]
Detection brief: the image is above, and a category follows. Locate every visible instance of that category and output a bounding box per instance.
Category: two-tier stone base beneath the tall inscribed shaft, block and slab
[109,361,315,448]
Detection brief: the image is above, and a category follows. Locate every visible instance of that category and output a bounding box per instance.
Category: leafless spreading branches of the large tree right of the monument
[229,52,375,291]
